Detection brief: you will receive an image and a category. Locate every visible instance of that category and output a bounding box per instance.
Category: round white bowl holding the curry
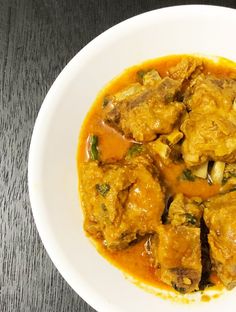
[28,6,236,312]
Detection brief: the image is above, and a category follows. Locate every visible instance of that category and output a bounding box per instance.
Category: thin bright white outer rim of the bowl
[28,4,236,311]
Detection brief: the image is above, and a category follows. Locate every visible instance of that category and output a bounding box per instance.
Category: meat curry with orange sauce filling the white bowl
[78,55,236,293]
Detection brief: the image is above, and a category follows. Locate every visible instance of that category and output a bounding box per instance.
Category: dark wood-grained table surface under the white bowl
[0,0,236,312]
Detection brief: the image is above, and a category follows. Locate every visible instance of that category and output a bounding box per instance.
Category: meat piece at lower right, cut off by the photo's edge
[204,192,236,289]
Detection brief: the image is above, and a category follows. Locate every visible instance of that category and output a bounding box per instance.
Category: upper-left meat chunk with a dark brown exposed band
[103,70,185,142]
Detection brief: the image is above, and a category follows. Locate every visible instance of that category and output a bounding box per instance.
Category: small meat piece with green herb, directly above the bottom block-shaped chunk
[167,194,203,227]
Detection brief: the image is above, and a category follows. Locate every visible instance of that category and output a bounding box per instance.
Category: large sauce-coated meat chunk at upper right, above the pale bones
[181,75,236,166]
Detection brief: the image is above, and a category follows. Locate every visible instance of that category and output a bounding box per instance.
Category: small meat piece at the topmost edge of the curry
[169,56,202,81]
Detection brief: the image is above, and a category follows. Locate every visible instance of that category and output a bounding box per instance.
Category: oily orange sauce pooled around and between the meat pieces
[77,56,236,290]
